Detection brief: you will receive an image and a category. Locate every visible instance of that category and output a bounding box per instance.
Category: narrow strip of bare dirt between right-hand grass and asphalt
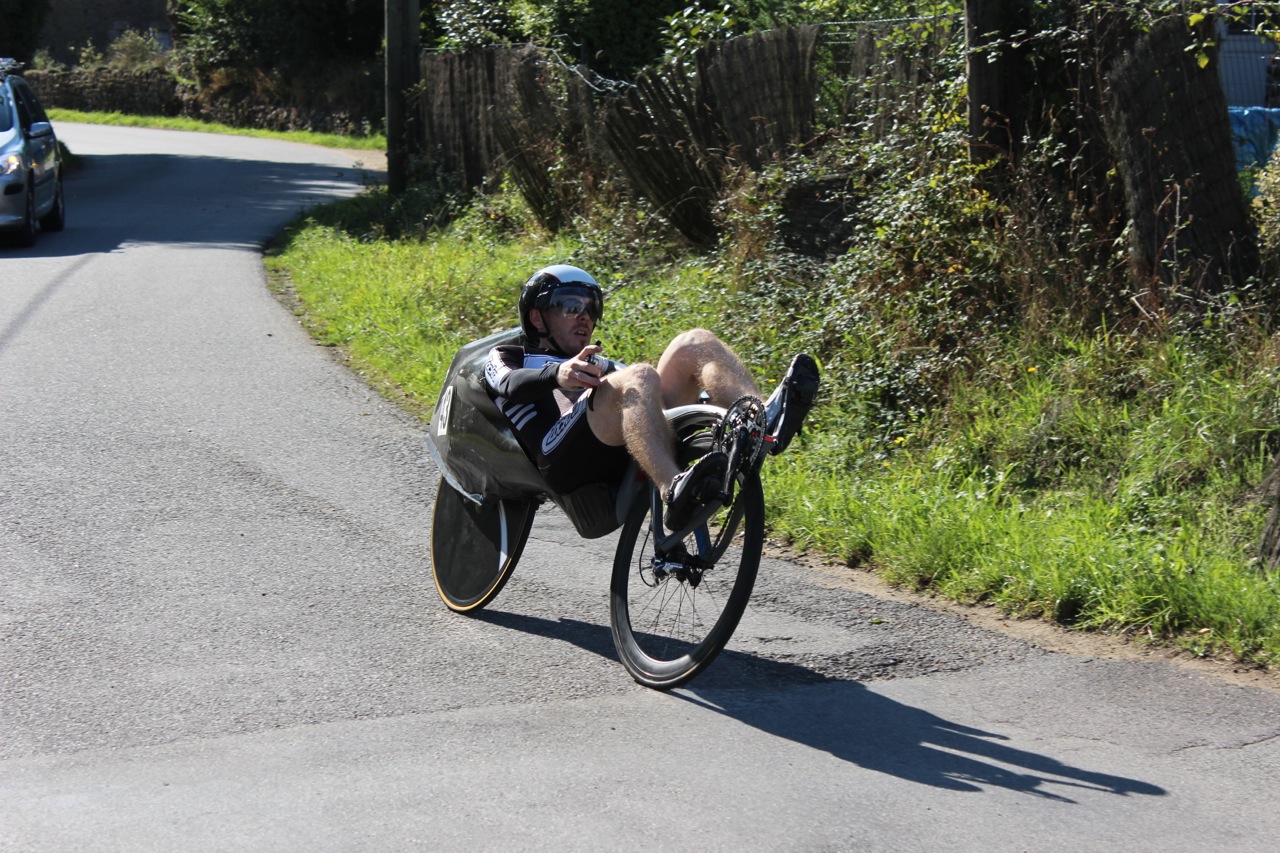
[768,540,1280,690]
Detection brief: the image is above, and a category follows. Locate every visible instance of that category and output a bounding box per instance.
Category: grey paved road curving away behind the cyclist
[0,126,1280,853]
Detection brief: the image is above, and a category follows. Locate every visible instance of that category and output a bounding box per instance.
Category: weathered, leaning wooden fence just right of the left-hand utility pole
[419,22,954,251]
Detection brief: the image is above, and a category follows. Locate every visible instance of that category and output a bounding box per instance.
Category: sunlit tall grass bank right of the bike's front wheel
[771,317,1280,665]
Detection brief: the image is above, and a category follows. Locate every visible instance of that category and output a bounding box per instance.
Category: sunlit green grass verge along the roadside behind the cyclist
[270,192,1280,665]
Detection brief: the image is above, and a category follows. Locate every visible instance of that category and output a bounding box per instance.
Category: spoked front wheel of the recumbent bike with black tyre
[609,471,764,690]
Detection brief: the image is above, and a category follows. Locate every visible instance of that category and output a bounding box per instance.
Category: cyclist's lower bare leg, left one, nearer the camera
[586,364,681,493]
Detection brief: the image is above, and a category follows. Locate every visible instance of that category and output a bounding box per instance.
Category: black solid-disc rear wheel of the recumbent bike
[431,478,538,613]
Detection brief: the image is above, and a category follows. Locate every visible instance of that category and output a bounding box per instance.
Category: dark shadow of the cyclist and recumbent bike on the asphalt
[476,611,1166,803]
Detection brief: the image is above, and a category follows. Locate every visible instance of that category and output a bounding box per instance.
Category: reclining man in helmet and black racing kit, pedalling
[485,264,818,530]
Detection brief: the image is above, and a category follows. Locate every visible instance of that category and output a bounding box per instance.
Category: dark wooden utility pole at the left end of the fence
[387,0,421,196]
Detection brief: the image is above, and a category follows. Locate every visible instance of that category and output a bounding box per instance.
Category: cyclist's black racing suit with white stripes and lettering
[485,345,630,492]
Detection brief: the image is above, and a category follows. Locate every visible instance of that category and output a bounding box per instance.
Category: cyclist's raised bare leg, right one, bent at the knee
[658,329,760,409]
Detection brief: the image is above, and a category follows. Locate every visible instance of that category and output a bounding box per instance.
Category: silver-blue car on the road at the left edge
[0,59,67,246]
